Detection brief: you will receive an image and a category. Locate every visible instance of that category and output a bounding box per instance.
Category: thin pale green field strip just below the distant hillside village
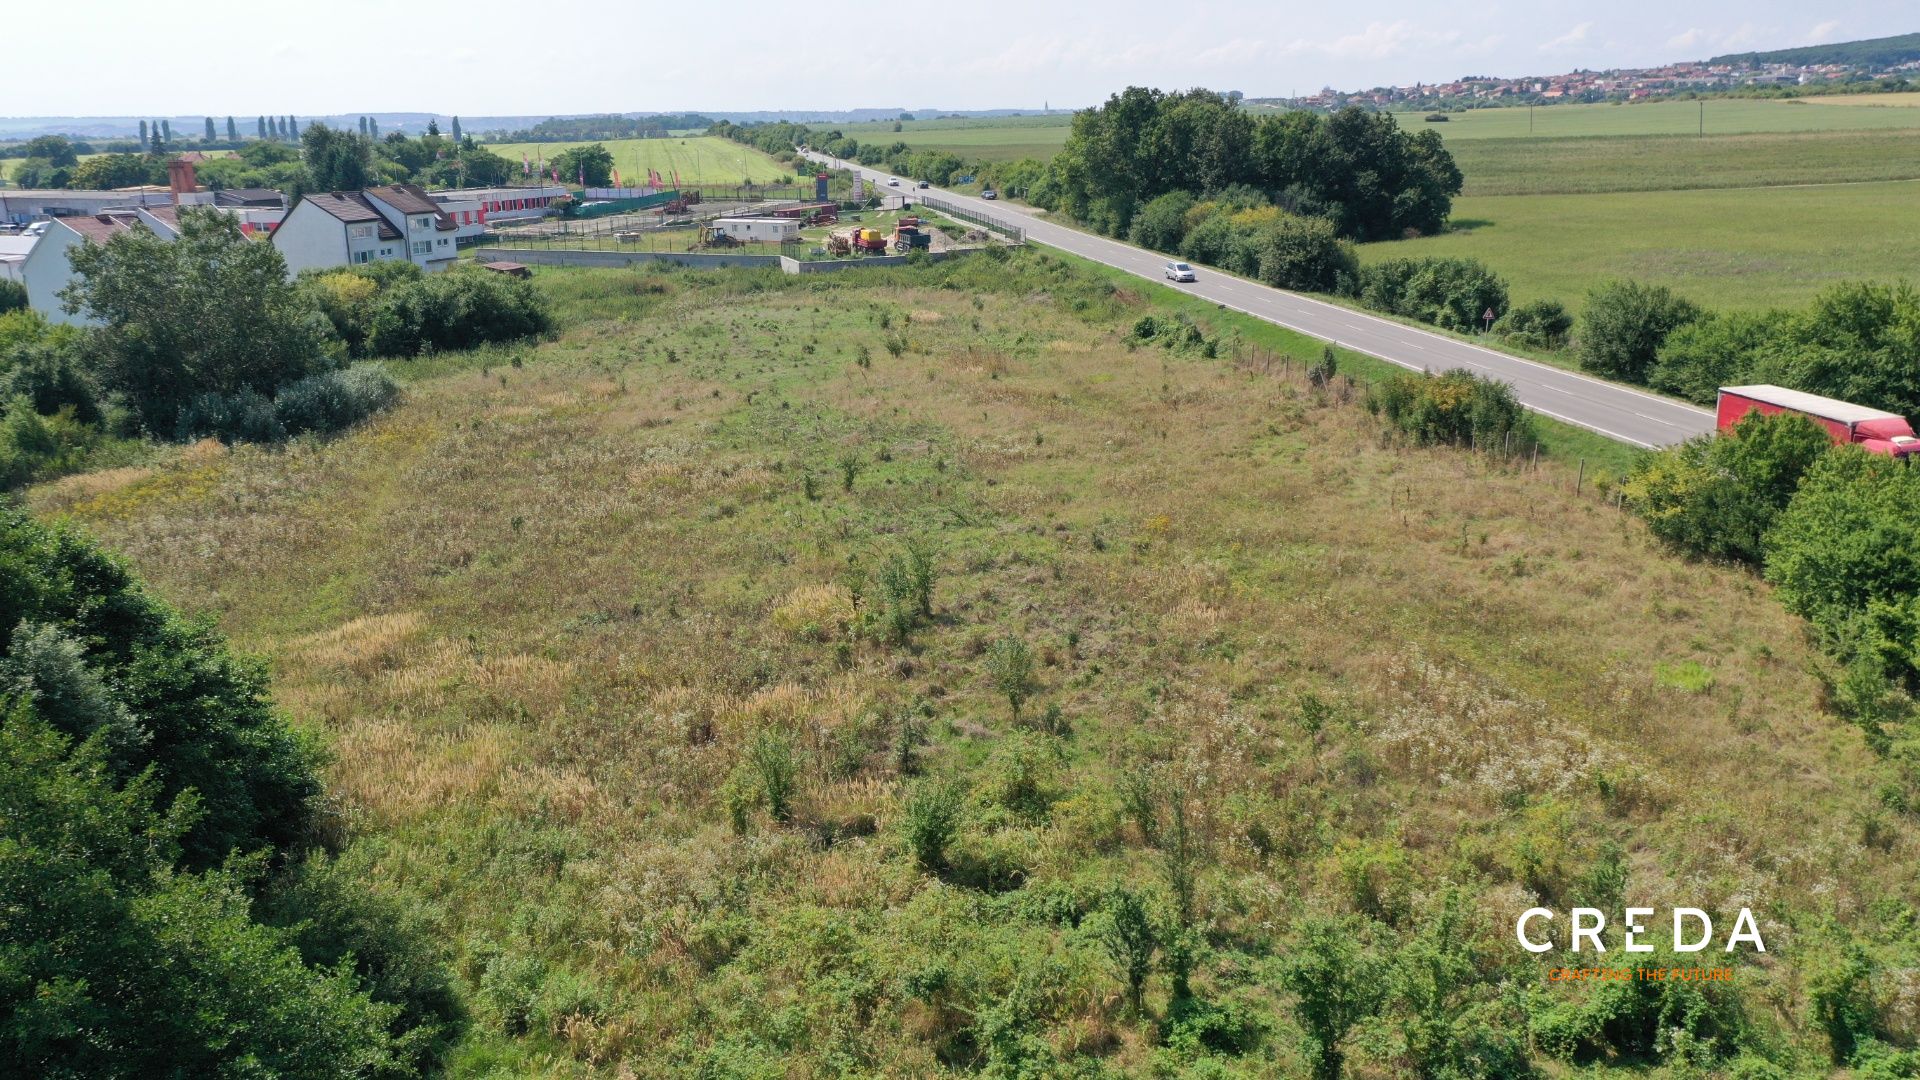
[1396,98,1920,142]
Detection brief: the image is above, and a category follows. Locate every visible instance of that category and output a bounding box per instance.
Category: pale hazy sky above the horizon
[15,0,1920,117]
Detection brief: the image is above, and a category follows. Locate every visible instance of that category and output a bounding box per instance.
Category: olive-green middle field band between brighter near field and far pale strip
[1448,129,1920,196]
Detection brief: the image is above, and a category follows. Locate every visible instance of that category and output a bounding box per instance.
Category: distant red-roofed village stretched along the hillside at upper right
[1275,60,1920,110]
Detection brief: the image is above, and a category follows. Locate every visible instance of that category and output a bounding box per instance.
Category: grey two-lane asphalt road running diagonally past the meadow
[812,154,1713,446]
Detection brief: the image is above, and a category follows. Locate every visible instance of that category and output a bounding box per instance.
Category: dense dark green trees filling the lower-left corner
[0,509,457,1078]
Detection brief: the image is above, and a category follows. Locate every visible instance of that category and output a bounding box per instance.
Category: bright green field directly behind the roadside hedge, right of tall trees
[1359,183,1920,307]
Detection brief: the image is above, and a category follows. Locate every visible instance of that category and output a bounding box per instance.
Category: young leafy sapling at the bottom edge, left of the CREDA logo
[1281,919,1386,1080]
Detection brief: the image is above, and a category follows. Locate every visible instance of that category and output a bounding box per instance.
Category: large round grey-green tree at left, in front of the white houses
[61,208,332,436]
